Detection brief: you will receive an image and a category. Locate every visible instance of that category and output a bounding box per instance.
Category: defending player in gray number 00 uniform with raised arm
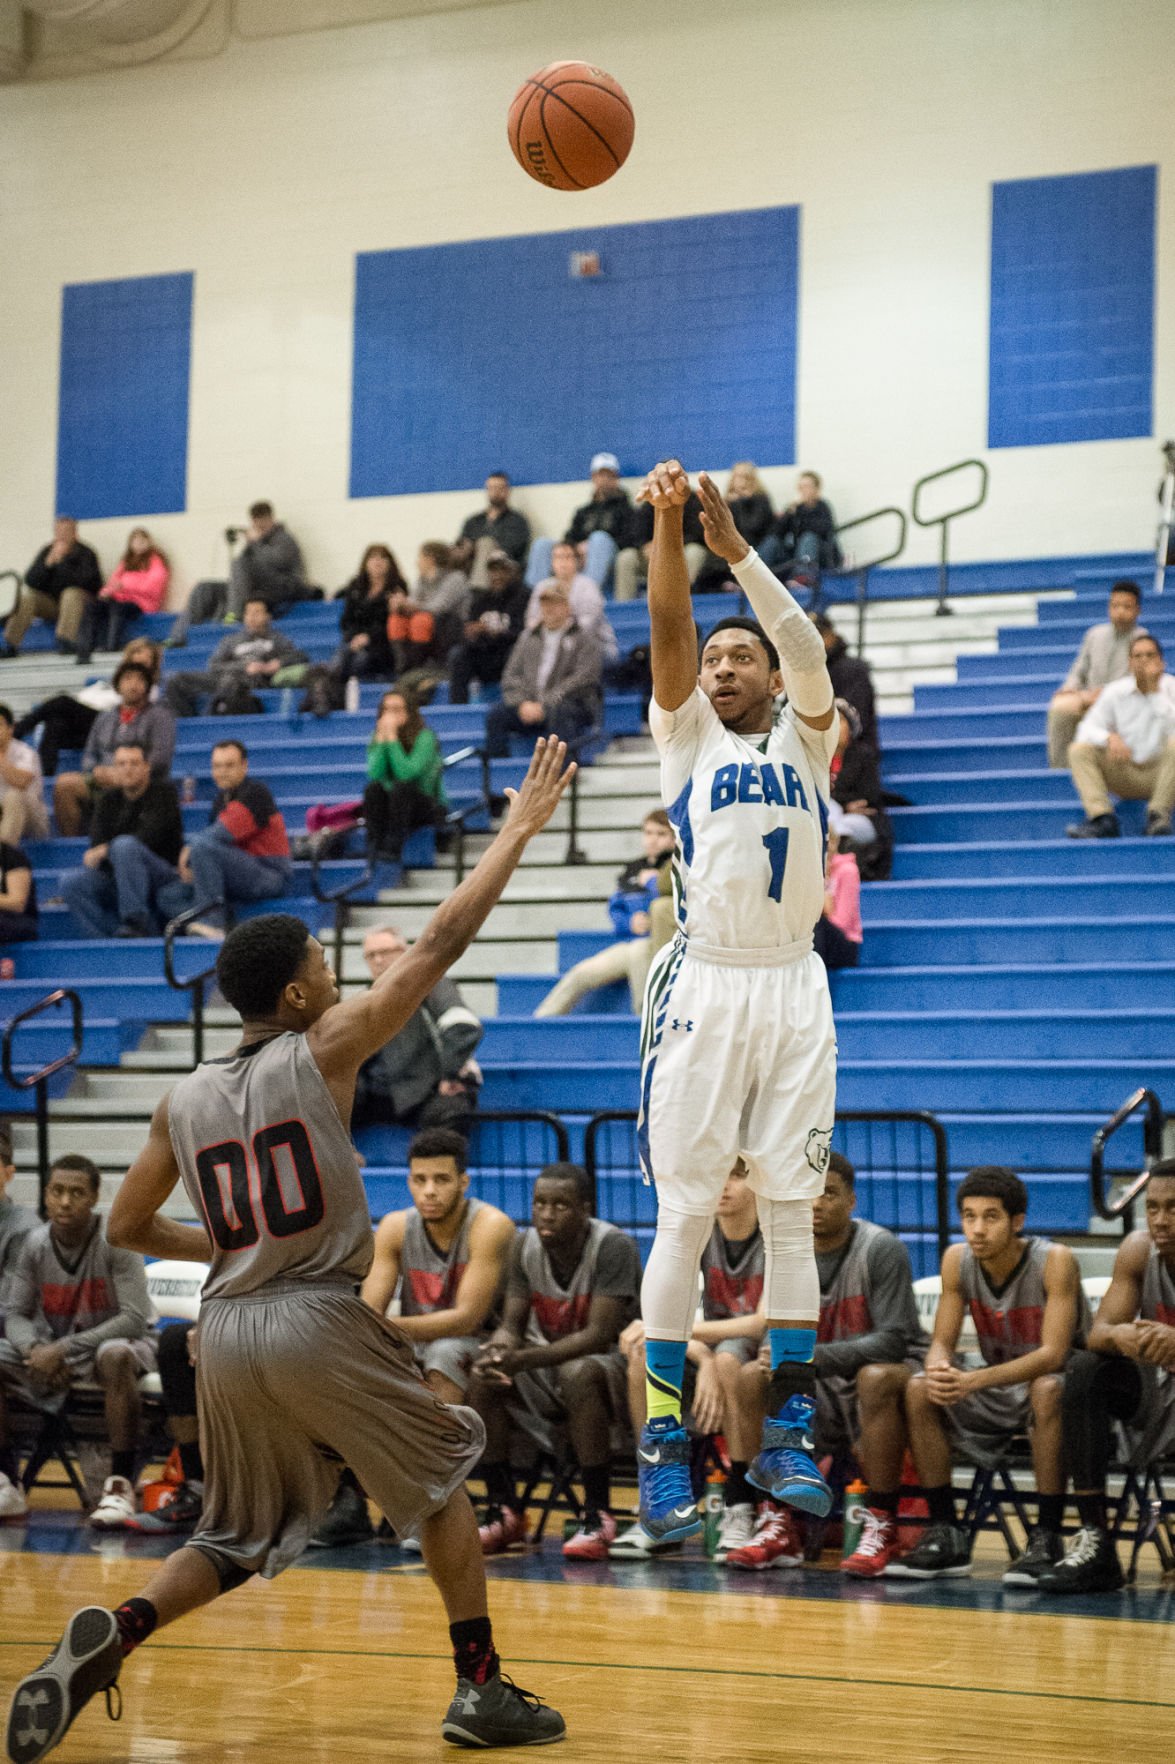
[7,741,573,1764]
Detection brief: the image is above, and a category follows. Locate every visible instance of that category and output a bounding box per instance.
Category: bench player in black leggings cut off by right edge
[1037,1157,1175,1593]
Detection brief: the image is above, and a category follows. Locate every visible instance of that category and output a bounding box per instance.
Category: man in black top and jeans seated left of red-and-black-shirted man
[60,741,187,937]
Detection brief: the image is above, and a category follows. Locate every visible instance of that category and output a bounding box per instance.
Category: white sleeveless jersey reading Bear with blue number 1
[649,686,840,951]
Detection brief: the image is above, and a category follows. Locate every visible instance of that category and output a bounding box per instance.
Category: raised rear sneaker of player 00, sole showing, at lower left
[9,1605,122,1764]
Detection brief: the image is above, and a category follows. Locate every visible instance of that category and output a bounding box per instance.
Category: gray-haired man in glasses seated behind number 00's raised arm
[351,924,483,1132]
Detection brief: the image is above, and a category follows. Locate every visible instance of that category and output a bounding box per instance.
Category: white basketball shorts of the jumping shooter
[637,938,836,1214]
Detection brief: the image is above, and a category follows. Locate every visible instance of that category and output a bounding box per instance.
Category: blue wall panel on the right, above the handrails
[988,166,1157,446]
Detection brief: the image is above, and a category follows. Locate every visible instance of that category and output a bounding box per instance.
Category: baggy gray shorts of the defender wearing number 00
[191,1282,485,1579]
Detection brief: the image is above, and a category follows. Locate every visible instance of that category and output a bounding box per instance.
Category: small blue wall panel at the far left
[56,273,192,520]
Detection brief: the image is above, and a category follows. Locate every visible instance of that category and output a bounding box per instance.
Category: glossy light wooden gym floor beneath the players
[0,1510,1175,1764]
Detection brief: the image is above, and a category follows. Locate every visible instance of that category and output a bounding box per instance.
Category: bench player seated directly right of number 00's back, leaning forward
[303,1127,515,1554]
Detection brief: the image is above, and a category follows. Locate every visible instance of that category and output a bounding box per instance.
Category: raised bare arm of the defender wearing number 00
[307,736,575,1083]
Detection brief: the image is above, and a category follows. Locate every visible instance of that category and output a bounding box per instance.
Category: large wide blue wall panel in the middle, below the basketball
[351,208,799,496]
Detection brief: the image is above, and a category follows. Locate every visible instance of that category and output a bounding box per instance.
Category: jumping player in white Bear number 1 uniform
[637,460,836,1540]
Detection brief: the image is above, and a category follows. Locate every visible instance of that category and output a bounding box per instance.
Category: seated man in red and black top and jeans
[180,741,291,937]
